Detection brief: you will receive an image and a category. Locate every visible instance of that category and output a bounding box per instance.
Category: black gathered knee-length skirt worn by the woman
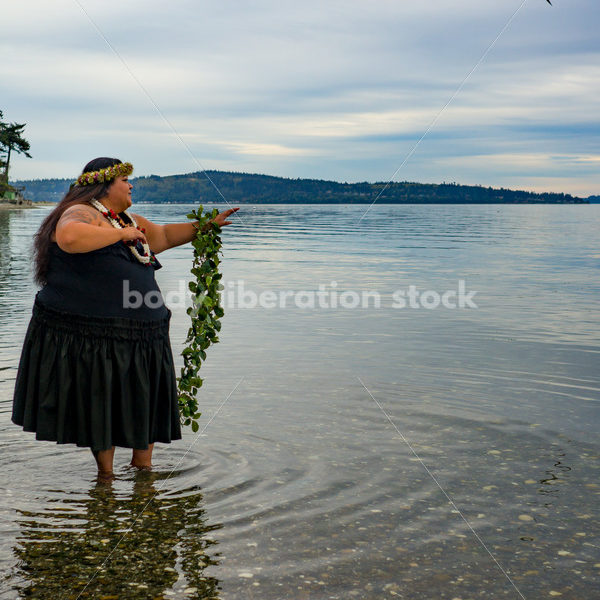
[12,299,181,450]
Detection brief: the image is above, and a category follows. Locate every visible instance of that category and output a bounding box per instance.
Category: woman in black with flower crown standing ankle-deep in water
[12,158,238,479]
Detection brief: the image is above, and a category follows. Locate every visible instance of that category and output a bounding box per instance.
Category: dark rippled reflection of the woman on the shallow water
[9,472,221,600]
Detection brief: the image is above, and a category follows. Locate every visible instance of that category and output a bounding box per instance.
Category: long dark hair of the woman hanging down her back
[33,157,122,286]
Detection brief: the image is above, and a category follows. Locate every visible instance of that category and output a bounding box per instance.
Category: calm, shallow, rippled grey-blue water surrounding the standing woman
[0,205,600,600]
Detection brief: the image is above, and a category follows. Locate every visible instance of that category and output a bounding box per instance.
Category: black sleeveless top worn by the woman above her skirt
[36,241,169,320]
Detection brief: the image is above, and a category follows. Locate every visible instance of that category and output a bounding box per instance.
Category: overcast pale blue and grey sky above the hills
[0,0,600,196]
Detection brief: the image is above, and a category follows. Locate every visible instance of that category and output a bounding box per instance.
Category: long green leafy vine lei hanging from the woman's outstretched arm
[177,205,224,433]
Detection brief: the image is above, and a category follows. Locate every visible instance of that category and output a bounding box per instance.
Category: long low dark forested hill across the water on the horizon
[13,171,587,204]
